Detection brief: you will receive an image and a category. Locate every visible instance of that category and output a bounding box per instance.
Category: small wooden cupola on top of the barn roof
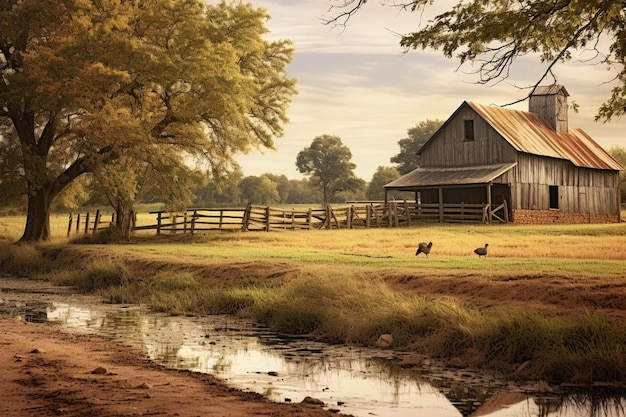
[528,84,569,133]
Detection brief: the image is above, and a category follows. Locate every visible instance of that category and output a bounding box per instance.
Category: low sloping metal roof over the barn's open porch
[385,162,517,190]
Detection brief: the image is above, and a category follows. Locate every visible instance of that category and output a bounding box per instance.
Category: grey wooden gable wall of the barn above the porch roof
[421,107,517,167]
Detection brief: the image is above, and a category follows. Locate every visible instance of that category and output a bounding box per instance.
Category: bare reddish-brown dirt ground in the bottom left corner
[0,318,336,417]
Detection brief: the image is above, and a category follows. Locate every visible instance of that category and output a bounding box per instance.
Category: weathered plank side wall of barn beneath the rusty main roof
[511,154,620,215]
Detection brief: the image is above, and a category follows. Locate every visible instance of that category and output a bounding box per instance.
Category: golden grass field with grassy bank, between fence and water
[0,215,626,384]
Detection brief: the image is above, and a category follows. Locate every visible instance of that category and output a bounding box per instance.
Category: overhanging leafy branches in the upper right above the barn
[327,0,626,121]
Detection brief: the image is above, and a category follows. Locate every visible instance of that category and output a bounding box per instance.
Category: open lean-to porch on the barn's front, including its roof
[385,162,516,223]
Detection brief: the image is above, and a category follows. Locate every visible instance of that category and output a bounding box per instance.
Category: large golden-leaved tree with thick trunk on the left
[0,0,295,241]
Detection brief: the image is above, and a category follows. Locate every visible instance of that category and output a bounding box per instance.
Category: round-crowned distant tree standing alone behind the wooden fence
[296,135,361,205]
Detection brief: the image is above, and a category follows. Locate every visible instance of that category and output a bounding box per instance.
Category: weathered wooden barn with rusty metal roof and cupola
[385,85,624,223]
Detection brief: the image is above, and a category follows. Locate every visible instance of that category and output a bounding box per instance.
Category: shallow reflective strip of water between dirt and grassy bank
[0,277,626,417]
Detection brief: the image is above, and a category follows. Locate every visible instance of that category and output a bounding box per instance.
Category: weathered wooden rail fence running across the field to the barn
[67,200,509,236]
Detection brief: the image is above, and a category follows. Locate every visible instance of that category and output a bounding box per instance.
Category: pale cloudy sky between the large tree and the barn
[237,0,626,181]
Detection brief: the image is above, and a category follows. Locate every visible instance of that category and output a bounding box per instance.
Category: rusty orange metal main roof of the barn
[465,102,626,171]
